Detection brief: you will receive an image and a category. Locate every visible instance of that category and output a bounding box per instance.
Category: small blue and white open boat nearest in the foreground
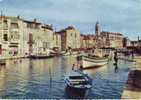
[65,70,92,96]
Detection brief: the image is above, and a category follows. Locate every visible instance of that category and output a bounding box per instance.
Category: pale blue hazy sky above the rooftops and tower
[0,0,141,40]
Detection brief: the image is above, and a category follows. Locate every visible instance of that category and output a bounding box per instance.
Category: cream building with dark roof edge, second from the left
[24,19,55,55]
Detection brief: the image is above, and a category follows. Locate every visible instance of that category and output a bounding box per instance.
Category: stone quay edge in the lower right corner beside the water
[121,57,141,99]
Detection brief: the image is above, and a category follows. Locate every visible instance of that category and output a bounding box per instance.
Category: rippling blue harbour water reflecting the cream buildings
[0,56,134,99]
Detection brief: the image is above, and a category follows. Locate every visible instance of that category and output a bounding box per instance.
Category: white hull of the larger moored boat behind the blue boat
[81,56,108,68]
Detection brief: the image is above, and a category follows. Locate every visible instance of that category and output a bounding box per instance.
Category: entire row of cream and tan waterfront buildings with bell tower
[0,16,133,58]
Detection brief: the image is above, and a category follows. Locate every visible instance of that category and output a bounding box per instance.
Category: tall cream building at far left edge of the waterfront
[0,16,23,58]
